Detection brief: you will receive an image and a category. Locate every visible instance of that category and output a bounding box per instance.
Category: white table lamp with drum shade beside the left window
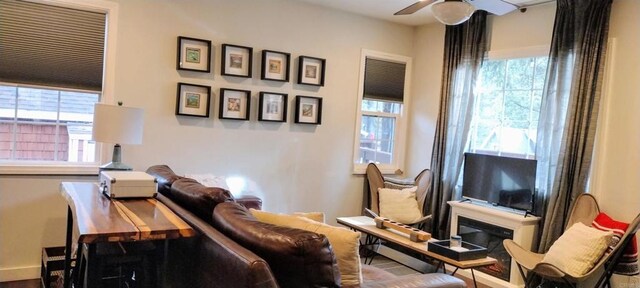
[91,102,144,171]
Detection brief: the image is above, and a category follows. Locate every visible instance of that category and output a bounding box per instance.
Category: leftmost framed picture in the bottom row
[176,83,211,117]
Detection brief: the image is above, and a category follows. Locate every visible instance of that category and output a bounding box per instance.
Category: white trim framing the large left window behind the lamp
[0,0,119,175]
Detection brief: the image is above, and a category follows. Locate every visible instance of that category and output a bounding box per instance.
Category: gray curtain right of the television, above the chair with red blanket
[536,0,612,253]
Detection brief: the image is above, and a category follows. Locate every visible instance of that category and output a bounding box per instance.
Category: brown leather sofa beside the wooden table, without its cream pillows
[147,165,466,288]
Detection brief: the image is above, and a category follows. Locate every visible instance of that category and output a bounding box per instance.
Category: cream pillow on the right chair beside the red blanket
[542,222,613,277]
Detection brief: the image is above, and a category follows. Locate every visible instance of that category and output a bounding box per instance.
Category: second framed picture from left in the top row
[220,44,253,78]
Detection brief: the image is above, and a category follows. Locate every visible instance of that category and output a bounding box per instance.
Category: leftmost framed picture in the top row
[176,36,211,73]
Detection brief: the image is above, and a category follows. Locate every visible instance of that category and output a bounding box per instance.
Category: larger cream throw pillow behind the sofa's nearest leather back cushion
[250,209,362,285]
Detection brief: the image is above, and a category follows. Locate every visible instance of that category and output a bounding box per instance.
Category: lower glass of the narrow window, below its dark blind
[358,99,402,164]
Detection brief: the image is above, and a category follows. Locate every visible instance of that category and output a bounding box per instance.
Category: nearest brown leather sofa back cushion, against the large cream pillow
[212,202,340,287]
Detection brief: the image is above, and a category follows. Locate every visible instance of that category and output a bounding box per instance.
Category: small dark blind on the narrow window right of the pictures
[363,58,407,102]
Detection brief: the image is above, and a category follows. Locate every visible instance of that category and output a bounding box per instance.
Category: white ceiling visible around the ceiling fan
[296,0,549,26]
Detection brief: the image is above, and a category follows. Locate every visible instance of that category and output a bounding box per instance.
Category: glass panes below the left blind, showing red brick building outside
[0,85,100,162]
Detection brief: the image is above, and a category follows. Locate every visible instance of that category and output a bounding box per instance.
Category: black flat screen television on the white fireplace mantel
[462,153,537,212]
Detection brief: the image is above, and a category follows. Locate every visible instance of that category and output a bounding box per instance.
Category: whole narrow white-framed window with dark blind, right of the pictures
[353,50,411,173]
